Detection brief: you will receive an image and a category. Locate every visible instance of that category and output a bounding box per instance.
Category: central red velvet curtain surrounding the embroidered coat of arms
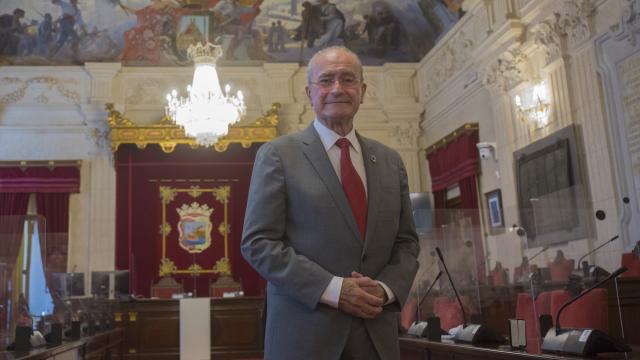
[115,144,265,296]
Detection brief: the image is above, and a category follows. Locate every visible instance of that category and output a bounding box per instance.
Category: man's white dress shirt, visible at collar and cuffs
[313,119,396,308]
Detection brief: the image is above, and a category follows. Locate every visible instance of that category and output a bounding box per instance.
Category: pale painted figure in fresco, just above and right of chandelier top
[211,0,263,60]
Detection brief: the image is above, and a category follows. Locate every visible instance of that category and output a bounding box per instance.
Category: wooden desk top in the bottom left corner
[0,329,123,360]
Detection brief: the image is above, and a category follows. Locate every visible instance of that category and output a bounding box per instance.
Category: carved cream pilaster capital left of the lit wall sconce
[482,49,528,91]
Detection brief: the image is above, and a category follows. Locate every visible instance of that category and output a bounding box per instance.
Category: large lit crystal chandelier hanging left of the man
[165,43,246,147]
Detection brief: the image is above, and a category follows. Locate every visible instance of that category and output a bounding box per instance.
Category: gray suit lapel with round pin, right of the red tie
[357,134,383,251]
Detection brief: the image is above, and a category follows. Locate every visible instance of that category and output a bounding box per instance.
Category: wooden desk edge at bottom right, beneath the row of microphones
[400,337,640,360]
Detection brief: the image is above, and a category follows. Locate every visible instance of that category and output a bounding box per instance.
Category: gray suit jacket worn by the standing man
[241,125,419,360]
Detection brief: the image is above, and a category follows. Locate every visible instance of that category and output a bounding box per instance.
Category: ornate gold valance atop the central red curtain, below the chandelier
[105,103,280,154]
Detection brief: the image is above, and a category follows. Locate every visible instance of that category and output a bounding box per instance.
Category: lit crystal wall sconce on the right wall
[513,81,551,129]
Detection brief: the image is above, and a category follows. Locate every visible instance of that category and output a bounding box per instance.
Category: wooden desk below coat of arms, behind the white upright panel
[115,297,264,360]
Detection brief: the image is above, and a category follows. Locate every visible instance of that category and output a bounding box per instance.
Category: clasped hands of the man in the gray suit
[338,271,387,319]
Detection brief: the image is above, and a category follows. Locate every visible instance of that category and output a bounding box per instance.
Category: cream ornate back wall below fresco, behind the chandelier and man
[0,59,421,271]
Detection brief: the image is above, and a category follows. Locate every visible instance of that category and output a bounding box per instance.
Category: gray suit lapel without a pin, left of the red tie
[301,125,362,244]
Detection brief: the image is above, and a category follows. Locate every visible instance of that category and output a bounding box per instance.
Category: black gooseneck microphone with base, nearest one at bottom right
[542,266,631,356]
